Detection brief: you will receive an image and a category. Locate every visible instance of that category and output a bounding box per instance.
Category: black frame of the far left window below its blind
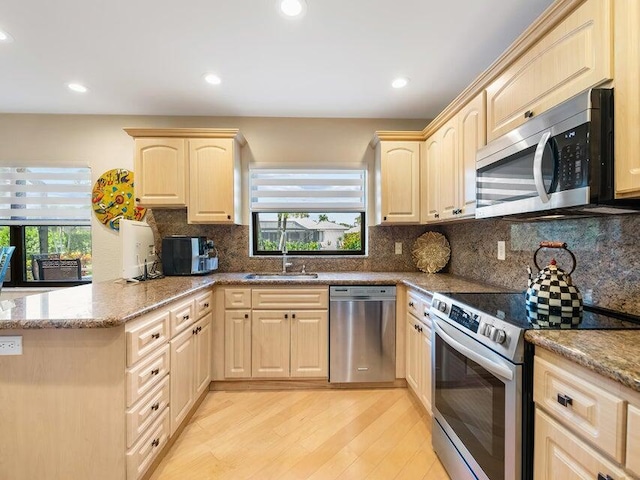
[0,224,93,288]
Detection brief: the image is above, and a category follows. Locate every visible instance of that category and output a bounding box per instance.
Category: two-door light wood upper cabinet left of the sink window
[125,129,244,224]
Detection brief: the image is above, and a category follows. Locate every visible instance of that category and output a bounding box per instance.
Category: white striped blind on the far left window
[0,167,91,225]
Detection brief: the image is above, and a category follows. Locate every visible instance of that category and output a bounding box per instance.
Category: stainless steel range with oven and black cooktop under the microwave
[430,293,640,480]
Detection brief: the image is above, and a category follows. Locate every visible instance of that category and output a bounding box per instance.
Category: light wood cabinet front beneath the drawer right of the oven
[534,409,631,480]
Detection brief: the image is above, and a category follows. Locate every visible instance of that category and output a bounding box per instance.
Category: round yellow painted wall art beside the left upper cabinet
[91,168,147,230]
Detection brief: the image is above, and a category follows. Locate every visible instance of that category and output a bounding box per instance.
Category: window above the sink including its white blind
[250,169,366,255]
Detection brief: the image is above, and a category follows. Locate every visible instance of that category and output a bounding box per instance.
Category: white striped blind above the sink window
[249,168,367,212]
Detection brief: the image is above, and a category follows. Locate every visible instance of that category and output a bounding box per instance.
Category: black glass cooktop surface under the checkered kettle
[446,292,640,330]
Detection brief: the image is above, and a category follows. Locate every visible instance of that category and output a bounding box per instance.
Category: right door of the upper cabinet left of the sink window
[187,138,235,223]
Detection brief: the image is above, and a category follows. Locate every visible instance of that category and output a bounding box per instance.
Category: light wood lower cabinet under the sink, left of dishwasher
[224,287,329,379]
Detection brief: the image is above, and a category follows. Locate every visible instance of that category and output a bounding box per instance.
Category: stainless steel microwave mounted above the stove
[476,88,640,218]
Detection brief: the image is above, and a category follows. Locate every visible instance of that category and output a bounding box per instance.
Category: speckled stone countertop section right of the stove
[524,330,640,392]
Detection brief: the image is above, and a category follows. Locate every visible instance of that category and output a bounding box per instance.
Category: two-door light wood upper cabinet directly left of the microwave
[421,93,485,223]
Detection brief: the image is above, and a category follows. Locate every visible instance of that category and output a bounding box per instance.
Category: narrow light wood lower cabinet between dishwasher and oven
[405,290,431,413]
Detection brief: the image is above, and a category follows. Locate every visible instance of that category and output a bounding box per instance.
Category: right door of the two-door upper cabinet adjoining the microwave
[457,92,487,217]
